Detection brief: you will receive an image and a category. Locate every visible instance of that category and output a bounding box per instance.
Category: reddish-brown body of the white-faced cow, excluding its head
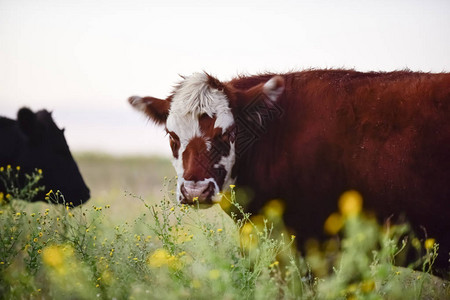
[230,70,450,266]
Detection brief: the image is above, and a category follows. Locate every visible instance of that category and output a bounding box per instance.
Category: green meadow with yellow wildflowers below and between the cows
[0,154,450,299]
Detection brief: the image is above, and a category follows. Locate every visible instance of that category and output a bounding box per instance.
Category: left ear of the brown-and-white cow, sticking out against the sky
[128,96,170,125]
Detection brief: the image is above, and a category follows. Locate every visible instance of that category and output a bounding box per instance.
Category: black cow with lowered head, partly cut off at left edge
[0,108,90,206]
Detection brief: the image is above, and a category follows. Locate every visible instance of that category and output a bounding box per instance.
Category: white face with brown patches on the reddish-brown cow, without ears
[166,73,236,203]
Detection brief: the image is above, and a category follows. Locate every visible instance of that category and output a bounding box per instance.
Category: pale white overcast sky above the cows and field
[0,0,450,155]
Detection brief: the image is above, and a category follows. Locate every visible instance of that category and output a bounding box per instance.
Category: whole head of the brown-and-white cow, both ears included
[129,73,284,203]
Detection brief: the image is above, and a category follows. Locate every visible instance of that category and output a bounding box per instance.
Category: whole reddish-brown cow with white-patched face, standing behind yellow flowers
[129,70,450,272]
